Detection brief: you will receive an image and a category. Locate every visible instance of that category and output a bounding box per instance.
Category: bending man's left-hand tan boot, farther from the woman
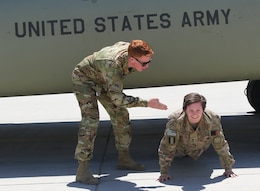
[76,161,98,184]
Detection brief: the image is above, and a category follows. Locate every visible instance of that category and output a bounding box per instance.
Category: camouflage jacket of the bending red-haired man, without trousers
[72,41,147,107]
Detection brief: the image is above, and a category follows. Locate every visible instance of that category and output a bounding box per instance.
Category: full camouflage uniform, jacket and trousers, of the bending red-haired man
[72,42,147,161]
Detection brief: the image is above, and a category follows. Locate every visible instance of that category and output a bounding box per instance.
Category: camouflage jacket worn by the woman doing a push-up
[158,110,235,174]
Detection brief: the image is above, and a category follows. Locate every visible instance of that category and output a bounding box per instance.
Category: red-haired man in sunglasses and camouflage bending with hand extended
[72,40,167,184]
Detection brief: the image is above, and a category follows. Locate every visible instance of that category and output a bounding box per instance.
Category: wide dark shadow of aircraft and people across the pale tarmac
[0,115,260,191]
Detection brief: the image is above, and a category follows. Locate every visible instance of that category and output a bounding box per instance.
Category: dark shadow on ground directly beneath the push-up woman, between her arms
[163,156,226,191]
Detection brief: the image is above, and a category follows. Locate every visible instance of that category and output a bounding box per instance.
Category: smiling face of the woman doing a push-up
[185,102,203,124]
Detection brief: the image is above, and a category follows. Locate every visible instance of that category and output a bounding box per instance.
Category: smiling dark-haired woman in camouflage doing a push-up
[158,93,237,182]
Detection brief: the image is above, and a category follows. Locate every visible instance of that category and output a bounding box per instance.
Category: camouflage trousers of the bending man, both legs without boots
[73,81,132,161]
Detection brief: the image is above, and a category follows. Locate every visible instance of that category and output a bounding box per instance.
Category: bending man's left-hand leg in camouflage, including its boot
[73,84,99,184]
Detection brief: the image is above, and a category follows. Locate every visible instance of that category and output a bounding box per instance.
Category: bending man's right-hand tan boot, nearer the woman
[117,150,145,171]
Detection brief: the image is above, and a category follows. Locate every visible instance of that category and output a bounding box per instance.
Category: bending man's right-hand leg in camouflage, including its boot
[99,93,144,170]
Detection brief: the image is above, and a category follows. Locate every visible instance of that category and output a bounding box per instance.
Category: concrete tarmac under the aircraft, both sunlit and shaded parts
[0,81,260,191]
